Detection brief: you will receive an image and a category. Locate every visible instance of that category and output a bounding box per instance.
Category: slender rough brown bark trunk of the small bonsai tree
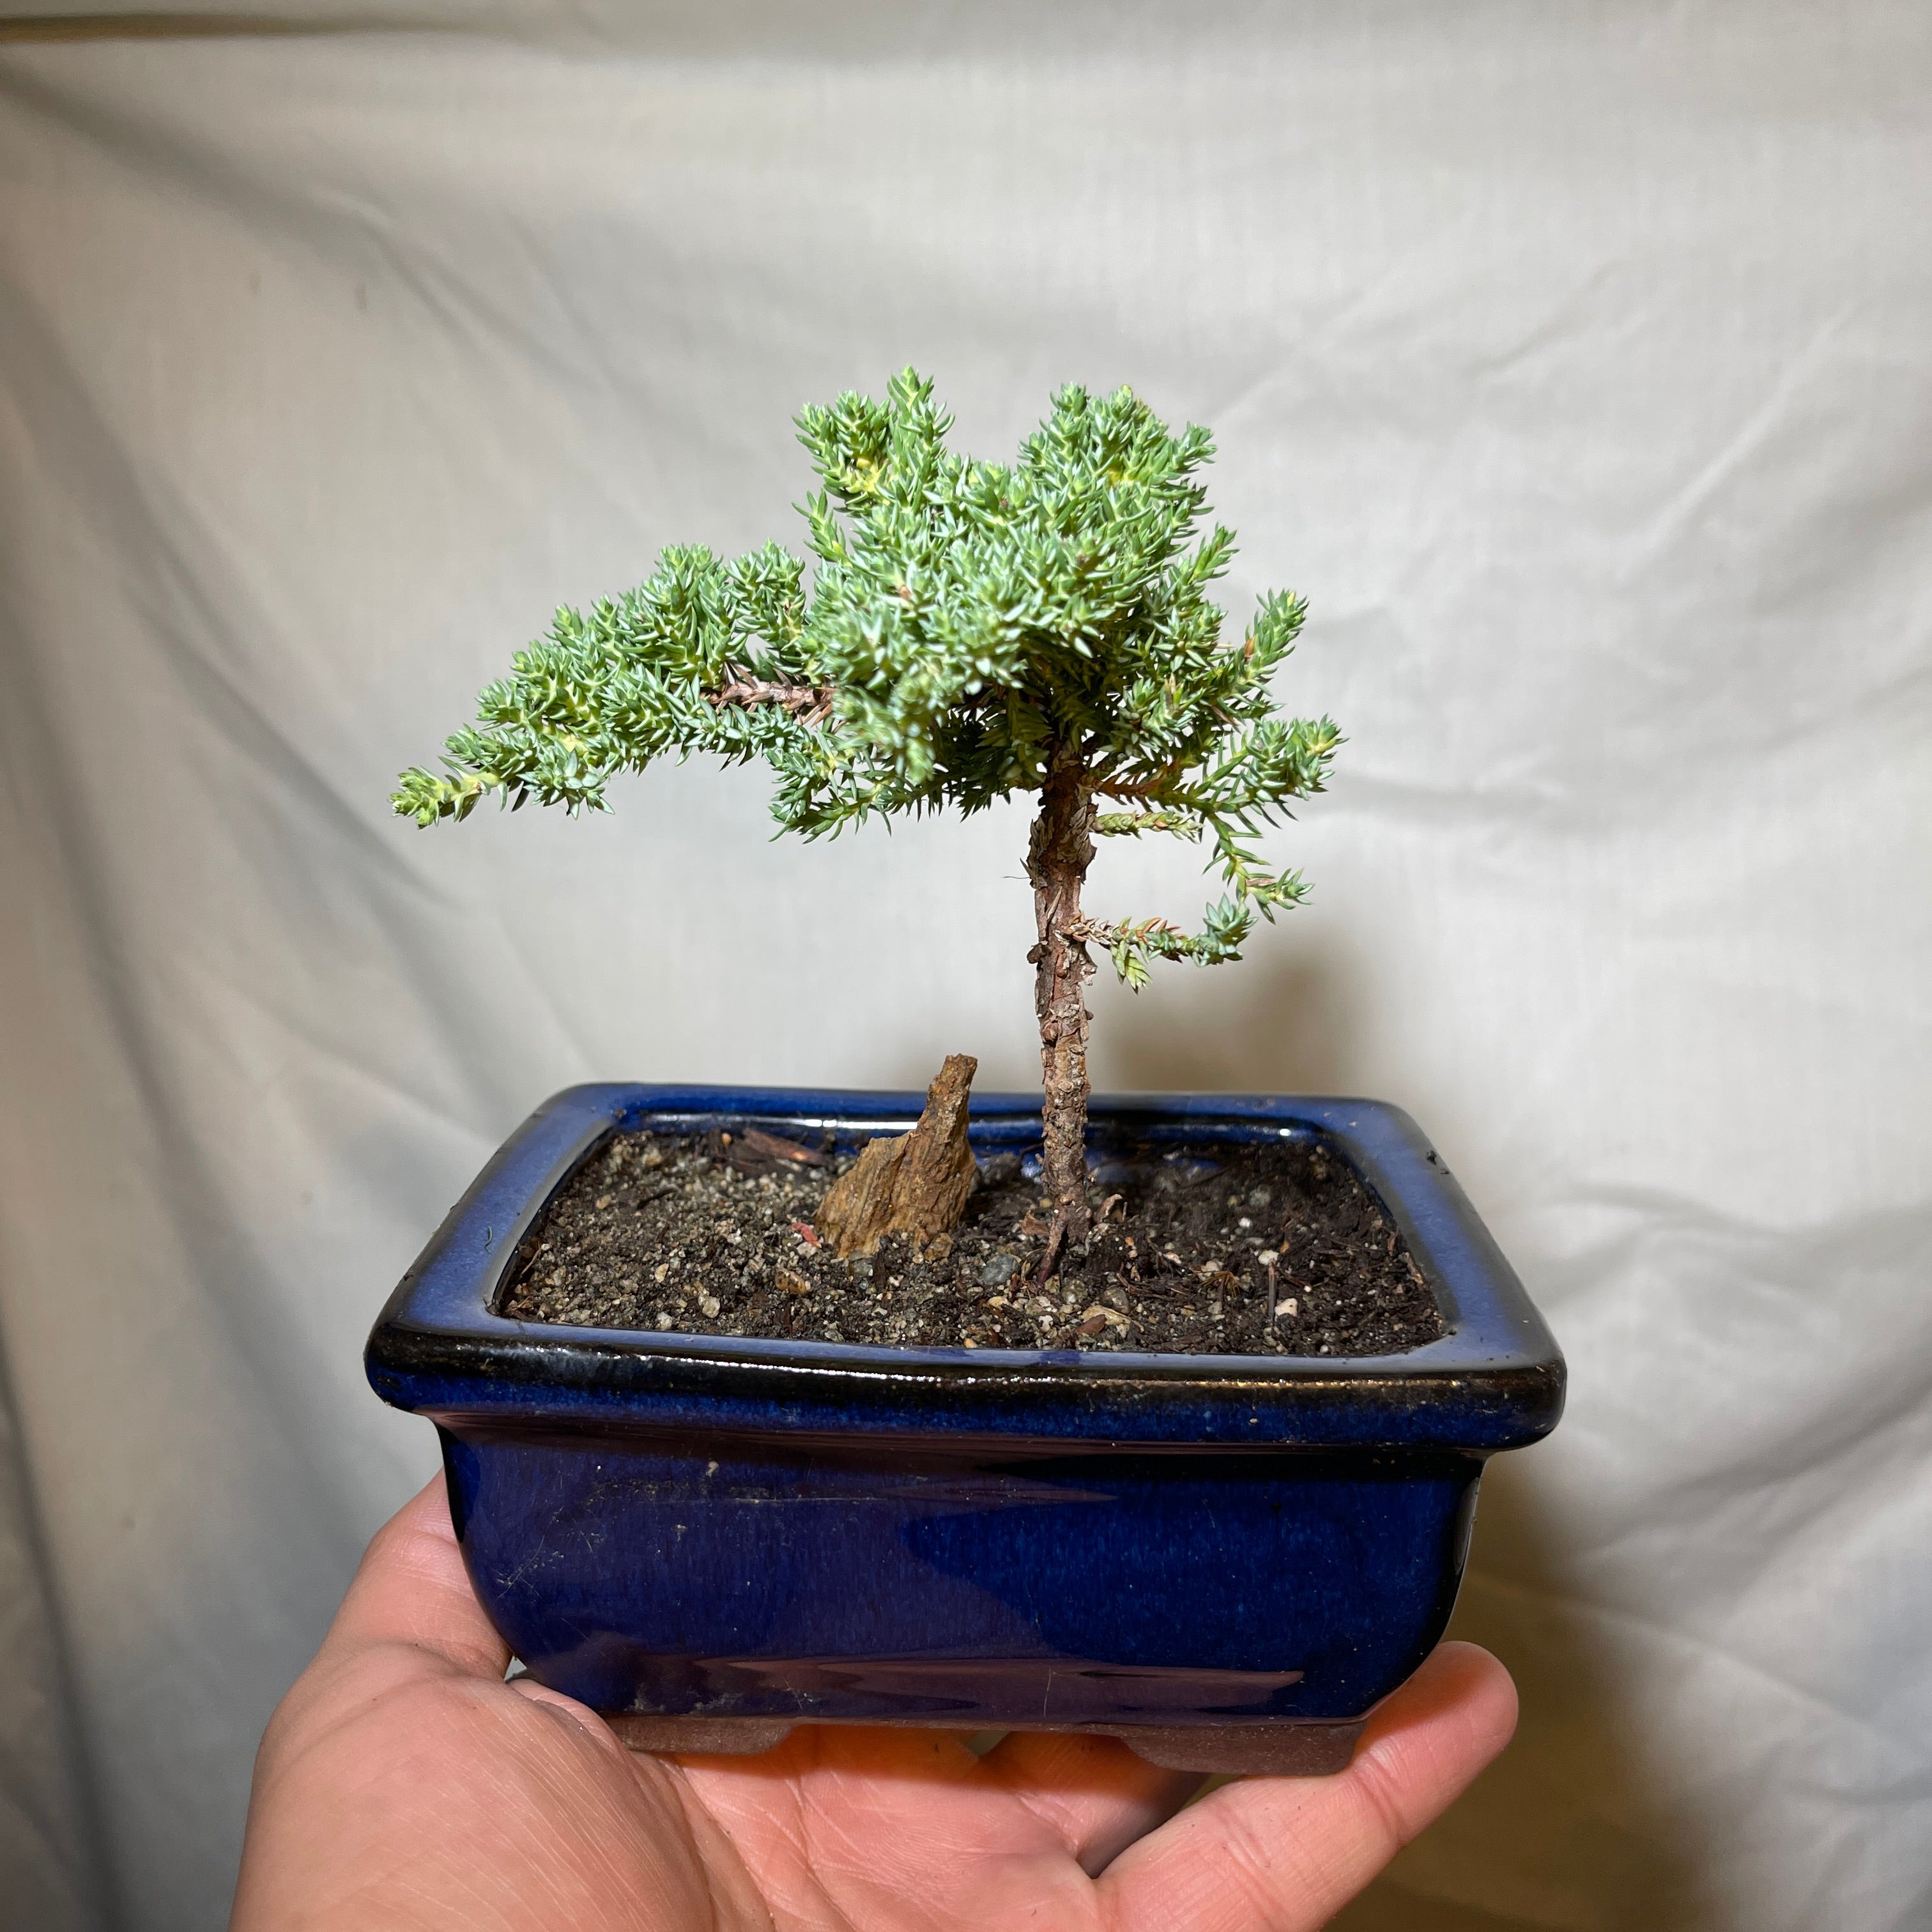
[1026,747,1094,1279]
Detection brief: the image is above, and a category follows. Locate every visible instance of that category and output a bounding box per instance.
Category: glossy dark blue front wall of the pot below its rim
[442,1430,1482,1727]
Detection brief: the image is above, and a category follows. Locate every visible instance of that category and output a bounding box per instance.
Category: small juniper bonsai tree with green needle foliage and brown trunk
[394,369,1341,1275]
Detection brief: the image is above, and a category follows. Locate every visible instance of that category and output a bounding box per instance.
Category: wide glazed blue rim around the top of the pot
[365,1082,1565,1453]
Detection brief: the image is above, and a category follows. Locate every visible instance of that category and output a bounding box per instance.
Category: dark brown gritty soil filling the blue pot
[500,1130,1443,1354]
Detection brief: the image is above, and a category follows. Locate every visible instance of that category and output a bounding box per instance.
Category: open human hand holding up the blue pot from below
[230,1478,1517,1932]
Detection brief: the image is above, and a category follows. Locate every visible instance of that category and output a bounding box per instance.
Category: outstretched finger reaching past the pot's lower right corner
[1098,1644,1517,1932]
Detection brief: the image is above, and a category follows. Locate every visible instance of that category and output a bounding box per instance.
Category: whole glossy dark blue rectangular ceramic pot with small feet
[367,1085,1563,1772]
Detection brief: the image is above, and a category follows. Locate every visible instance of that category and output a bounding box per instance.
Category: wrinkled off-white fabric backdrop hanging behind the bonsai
[0,0,1932,1932]
